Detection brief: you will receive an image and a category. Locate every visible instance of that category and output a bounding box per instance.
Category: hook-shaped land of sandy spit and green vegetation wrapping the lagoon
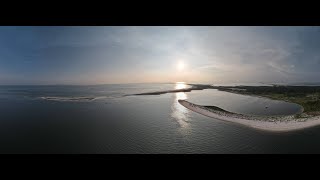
[179,85,320,132]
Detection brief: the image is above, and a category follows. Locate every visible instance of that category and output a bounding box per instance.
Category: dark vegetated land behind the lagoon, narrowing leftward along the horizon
[131,83,320,115]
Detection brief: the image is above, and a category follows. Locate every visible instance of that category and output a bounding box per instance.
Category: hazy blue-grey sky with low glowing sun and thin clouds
[0,26,320,85]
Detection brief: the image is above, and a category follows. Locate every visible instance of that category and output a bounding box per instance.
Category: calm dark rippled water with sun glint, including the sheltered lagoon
[0,84,320,153]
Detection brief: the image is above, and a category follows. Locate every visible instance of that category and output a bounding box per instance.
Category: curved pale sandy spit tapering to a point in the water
[178,100,320,132]
